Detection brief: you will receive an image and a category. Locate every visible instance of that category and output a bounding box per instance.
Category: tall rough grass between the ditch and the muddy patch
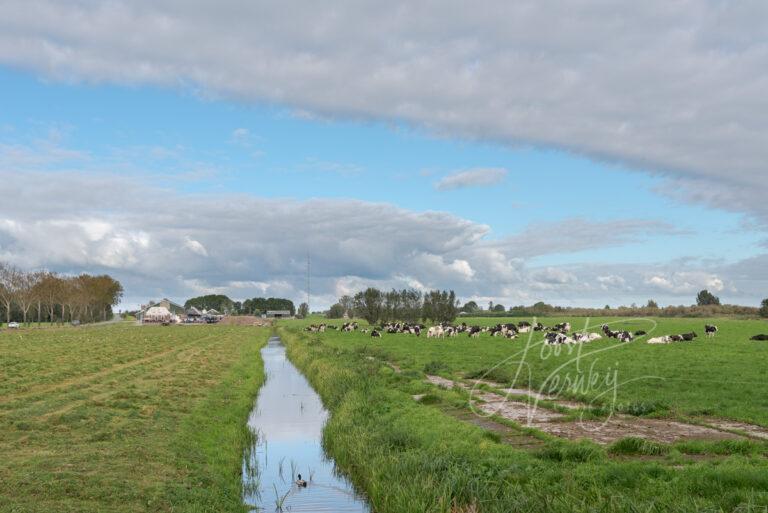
[279,323,768,513]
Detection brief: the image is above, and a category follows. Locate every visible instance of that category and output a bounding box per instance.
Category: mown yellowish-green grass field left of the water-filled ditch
[0,325,269,512]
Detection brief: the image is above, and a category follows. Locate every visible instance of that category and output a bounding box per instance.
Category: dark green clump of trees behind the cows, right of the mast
[327,287,459,324]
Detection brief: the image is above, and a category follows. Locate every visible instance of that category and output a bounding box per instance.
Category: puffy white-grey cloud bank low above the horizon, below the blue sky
[0,170,768,308]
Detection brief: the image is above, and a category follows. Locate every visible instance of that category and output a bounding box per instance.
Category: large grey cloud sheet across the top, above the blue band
[0,0,768,222]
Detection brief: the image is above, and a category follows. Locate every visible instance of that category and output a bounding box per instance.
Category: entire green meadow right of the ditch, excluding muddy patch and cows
[278,318,768,513]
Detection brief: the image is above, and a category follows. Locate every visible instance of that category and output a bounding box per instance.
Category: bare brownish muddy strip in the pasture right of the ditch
[427,376,744,444]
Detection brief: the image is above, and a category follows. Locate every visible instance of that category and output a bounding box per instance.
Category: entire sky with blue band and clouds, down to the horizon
[0,0,768,309]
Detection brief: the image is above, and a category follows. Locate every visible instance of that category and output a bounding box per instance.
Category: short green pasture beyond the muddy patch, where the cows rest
[290,318,768,426]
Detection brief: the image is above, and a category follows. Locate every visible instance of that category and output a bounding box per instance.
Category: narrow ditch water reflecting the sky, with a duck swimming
[243,337,370,513]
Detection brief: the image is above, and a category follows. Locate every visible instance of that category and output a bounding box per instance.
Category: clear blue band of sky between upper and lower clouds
[0,67,763,262]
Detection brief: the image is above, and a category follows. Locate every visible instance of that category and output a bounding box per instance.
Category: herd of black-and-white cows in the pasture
[305,321,768,344]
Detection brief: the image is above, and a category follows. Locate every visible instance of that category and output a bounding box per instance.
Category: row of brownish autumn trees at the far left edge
[0,262,123,324]
